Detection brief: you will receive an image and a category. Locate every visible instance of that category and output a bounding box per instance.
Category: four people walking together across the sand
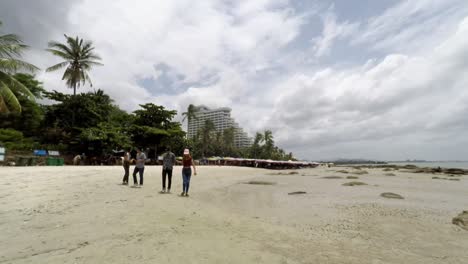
[122,148,197,196]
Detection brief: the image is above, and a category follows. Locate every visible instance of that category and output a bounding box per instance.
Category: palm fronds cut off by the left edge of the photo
[0,21,38,113]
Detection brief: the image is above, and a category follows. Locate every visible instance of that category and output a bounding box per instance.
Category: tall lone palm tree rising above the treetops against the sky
[46,35,103,95]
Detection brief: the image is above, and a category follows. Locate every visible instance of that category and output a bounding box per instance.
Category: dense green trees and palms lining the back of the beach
[0,20,292,159]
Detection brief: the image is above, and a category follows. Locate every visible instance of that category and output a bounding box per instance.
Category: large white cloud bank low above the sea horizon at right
[270,17,468,159]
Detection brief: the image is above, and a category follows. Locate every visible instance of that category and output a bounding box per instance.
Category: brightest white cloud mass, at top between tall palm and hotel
[60,0,302,110]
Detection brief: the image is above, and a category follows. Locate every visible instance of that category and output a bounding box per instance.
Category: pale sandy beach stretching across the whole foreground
[0,166,468,264]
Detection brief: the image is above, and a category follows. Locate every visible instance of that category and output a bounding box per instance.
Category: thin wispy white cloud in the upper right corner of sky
[352,0,468,54]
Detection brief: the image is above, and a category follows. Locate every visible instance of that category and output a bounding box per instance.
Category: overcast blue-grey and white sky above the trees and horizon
[0,0,468,160]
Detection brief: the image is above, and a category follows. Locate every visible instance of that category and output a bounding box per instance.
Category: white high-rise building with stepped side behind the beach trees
[187,105,252,147]
